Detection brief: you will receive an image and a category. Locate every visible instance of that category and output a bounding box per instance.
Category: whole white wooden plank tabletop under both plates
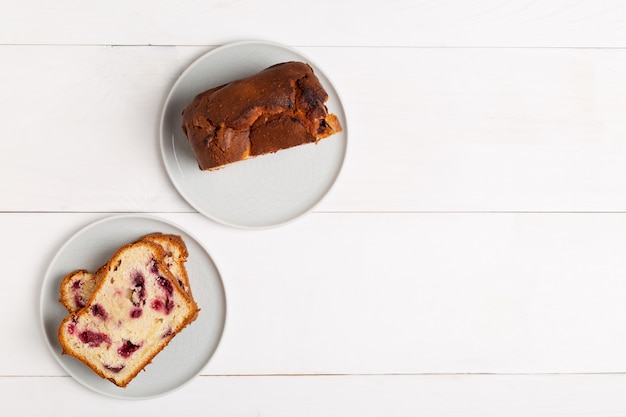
[0,0,626,417]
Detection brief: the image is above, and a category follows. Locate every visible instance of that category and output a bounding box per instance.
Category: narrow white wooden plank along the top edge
[0,0,626,47]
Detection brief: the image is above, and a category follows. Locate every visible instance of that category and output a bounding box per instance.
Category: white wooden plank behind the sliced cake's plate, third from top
[7,213,626,376]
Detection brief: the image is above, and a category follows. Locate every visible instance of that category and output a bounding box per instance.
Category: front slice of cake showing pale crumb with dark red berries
[58,240,199,387]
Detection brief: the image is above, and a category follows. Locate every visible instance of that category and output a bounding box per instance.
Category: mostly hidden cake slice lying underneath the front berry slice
[59,233,193,312]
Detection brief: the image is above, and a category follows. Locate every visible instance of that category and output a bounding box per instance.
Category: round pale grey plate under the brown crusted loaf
[161,41,348,228]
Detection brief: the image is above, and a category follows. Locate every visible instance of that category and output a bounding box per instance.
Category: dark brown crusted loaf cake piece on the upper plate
[182,62,342,170]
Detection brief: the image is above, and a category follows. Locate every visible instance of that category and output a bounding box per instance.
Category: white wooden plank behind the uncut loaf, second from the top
[0,46,626,212]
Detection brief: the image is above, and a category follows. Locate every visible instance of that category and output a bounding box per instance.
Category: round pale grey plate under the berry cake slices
[40,215,226,399]
